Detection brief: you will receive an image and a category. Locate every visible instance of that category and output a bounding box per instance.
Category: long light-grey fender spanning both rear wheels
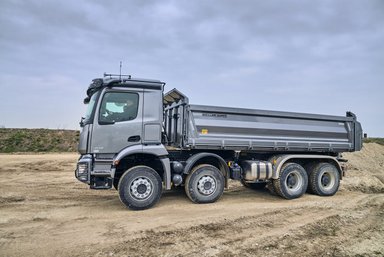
[271,154,343,179]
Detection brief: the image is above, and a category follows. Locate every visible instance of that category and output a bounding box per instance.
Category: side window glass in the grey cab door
[99,92,139,124]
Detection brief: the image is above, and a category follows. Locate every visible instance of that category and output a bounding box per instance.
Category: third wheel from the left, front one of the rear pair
[273,163,308,199]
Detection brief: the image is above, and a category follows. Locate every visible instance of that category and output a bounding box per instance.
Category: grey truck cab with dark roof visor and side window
[76,74,169,194]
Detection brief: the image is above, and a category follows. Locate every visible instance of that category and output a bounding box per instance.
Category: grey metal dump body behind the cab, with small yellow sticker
[165,88,362,153]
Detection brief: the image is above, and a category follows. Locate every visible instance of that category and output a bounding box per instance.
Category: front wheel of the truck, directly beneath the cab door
[118,166,162,210]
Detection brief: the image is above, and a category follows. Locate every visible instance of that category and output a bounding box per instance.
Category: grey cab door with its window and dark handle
[91,88,143,153]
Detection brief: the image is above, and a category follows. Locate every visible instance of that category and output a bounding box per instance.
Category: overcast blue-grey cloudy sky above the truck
[0,0,384,137]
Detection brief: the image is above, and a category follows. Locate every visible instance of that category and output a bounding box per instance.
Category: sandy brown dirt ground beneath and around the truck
[0,143,384,256]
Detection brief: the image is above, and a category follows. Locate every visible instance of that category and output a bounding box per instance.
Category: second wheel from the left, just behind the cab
[185,164,225,203]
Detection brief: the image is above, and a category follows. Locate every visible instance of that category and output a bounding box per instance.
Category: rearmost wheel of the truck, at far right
[309,162,340,196]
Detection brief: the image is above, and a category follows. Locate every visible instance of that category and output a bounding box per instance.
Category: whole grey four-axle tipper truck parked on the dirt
[75,74,362,210]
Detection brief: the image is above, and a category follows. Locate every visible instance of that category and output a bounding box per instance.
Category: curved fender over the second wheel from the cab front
[183,153,229,188]
